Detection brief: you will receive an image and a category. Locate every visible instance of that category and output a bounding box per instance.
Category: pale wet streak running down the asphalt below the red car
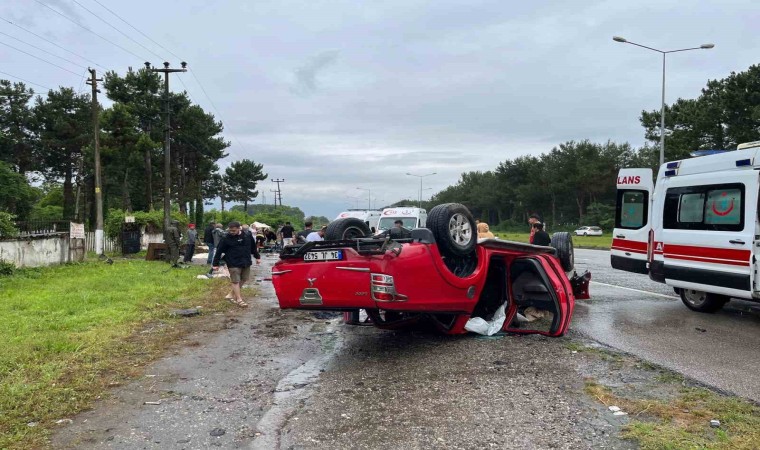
[251,319,343,450]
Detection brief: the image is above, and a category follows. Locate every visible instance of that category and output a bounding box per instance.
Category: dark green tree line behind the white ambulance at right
[428,65,760,230]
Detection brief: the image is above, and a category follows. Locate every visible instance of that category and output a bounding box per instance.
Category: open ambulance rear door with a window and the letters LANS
[610,169,654,273]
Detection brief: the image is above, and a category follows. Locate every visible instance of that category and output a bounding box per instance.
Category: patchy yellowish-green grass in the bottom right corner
[585,379,760,450]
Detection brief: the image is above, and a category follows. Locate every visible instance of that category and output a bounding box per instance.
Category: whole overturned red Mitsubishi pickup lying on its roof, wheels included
[272,203,590,336]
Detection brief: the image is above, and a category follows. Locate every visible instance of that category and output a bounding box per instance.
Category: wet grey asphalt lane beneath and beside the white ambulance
[571,249,760,401]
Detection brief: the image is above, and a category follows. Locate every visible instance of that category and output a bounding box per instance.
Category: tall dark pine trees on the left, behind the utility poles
[0,69,267,236]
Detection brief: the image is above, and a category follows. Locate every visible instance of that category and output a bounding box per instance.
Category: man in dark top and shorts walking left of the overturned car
[213,222,261,307]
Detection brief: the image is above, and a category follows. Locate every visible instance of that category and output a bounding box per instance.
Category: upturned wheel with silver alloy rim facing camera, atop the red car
[427,203,478,257]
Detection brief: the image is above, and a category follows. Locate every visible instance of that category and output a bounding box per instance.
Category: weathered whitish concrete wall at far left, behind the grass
[0,233,69,267]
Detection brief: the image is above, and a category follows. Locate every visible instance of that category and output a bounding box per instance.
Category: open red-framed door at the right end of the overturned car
[503,254,575,337]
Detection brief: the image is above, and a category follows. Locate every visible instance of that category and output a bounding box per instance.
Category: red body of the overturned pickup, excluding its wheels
[272,239,590,336]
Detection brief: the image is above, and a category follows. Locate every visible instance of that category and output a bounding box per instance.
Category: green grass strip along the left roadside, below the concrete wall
[0,259,229,448]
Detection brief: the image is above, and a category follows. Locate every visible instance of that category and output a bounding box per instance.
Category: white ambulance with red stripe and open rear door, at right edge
[611,141,760,312]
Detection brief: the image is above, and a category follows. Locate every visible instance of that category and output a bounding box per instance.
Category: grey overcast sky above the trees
[0,0,760,218]
